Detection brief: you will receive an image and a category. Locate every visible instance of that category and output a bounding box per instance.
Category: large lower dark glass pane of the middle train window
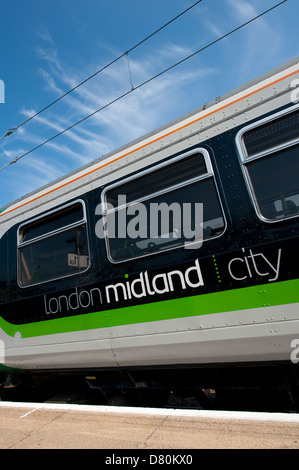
[107,177,225,261]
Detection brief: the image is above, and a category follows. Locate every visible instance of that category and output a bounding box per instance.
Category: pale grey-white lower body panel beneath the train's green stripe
[1,304,299,369]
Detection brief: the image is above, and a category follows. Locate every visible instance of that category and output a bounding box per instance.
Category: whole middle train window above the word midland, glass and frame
[102,149,225,262]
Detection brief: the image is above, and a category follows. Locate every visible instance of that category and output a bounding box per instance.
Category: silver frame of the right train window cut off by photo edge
[235,104,299,224]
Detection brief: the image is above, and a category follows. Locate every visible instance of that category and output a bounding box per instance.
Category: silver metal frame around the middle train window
[101,147,227,264]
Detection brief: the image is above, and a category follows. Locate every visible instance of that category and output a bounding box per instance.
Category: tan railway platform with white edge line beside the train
[0,402,299,452]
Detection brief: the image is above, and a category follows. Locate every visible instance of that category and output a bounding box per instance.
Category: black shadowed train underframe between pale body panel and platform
[0,362,299,413]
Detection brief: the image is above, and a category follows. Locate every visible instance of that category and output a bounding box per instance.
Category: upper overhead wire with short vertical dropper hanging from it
[0,0,203,140]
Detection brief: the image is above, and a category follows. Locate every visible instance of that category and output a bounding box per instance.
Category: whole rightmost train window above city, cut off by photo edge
[237,107,299,222]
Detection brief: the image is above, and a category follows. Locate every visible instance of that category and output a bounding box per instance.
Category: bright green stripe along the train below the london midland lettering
[0,279,299,338]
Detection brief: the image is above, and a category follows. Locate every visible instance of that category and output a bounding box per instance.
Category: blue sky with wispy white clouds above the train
[0,0,299,207]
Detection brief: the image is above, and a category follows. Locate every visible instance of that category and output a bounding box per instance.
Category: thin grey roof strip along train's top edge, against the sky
[0,56,299,214]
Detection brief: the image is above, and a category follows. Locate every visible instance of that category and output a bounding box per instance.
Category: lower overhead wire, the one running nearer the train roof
[0,0,287,171]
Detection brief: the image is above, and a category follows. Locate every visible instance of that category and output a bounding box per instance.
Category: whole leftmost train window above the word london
[18,201,89,287]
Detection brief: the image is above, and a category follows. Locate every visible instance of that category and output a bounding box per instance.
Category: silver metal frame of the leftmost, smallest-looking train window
[17,199,91,289]
